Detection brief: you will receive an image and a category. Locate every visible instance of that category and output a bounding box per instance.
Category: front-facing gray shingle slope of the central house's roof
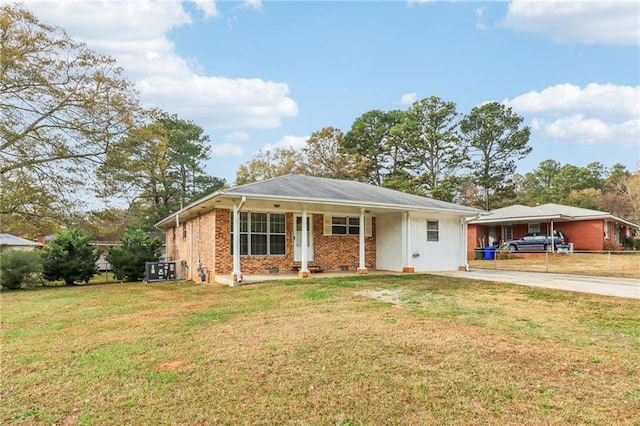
[220,174,483,215]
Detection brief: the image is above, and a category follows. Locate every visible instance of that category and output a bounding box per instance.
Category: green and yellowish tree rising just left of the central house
[98,111,224,229]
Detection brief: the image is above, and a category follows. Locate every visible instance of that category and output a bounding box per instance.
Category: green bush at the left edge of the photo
[0,250,42,289]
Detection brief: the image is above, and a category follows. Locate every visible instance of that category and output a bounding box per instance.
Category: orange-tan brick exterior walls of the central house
[167,209,376,283]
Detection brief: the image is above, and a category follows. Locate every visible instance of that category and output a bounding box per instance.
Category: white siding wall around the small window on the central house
[409,213,466,272]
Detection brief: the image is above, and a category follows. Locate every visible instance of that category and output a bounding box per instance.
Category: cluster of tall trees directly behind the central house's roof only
[236,100,531,213]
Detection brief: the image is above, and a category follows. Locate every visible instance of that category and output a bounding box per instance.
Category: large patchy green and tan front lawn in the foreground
[0,275,640,425]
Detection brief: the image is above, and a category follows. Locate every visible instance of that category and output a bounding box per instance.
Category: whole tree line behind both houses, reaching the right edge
[235,106,640,223]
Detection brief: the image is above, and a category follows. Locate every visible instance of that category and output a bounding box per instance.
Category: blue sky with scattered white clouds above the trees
[8,0,640,183]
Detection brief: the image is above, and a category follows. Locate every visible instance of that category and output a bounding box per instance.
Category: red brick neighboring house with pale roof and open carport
[467,204,640,259]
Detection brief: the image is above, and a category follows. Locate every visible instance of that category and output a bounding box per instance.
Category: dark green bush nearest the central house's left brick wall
[107,229,162,281]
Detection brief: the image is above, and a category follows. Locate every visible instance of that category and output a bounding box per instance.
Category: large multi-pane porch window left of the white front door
[231,212,287,256]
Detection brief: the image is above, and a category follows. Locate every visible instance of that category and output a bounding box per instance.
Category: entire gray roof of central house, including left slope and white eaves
[156,174,486,227]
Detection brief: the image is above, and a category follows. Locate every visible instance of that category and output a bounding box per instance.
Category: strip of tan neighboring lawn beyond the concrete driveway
[469,252,640,278]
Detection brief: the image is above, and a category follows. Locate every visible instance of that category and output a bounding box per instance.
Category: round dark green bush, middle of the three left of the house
[42,229,100,285]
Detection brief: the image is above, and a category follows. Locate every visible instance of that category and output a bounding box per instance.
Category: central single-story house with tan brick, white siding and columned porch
[156,174,482,285]
